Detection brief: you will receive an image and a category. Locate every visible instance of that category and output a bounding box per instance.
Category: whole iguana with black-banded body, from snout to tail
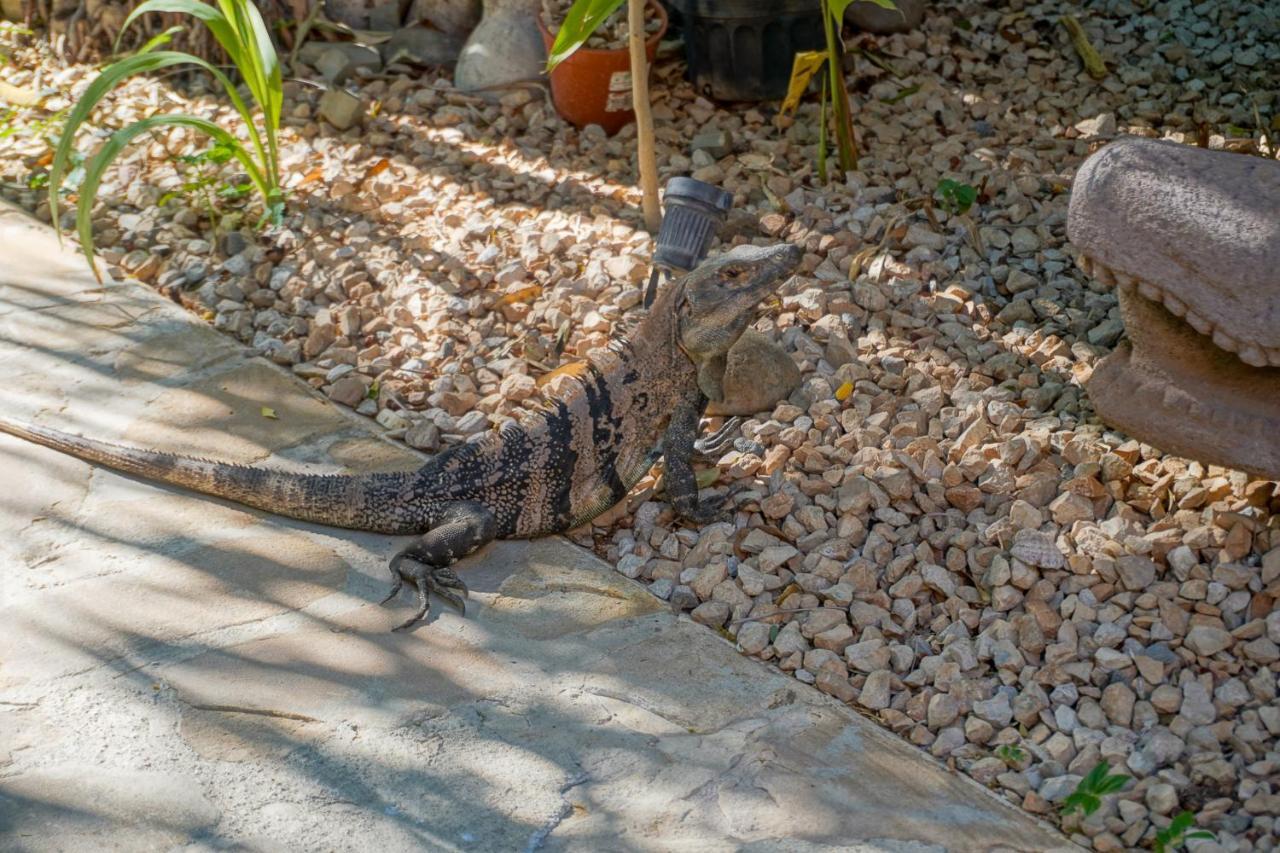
[0,243,801,630]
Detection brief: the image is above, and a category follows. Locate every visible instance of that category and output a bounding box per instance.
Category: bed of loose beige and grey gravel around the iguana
[0,0,1280,850]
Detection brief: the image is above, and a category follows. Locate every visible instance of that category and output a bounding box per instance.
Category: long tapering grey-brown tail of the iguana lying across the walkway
[0,416,426,534]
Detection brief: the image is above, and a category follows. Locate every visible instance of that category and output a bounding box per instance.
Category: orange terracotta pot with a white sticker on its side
[538,0,667,136]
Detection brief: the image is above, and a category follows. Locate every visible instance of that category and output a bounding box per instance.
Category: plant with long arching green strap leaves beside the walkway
[49,0,284,282]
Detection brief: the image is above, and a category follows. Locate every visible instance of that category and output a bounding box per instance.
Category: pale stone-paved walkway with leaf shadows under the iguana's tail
[0,209,1066,852]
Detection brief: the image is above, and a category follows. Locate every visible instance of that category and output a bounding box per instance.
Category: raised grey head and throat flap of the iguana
[668,243,804,400]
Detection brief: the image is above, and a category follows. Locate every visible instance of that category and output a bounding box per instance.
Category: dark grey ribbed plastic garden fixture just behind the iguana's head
[644,178,733,307]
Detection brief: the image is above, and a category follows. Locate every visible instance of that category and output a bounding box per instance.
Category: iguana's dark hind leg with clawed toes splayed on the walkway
[381,501,498,630]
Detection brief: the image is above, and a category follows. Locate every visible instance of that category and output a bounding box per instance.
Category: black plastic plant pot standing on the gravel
[667,0,827,101]
